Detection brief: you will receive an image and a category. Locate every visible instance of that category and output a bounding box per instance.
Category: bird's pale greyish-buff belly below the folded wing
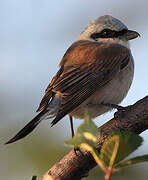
[70,60,134,119]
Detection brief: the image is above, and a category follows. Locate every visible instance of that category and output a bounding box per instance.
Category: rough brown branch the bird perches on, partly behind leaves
[41,96,148,180]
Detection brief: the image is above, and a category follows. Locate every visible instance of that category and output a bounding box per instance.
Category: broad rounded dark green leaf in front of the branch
[100,132,143,167]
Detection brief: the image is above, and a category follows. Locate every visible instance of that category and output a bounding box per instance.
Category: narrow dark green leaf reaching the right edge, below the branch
[115,154,148,168]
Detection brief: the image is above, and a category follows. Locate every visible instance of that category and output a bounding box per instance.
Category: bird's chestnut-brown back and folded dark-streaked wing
[39,41,130,125]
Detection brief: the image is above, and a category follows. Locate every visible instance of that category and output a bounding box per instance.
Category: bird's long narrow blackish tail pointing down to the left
[5,110,47,144]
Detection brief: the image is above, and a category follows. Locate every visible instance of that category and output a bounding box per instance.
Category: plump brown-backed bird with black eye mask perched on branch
[5,15,140,144]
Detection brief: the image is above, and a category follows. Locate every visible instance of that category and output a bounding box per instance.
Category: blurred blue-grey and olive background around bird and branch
[0,0,148,180]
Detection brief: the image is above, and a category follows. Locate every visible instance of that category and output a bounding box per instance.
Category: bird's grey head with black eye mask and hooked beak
[78,15,140,47]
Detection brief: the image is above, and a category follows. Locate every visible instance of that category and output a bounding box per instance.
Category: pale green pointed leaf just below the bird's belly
[65,111,98,148]
